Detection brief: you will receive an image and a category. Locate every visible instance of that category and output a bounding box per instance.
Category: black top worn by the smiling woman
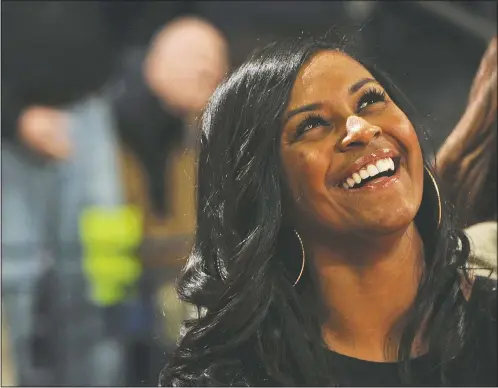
[328,277,498,387]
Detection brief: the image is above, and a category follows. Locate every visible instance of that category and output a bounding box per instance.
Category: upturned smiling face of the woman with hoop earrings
[281,51,423,237]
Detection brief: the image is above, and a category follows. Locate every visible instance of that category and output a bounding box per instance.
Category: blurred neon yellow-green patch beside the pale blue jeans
[80,206,143,306]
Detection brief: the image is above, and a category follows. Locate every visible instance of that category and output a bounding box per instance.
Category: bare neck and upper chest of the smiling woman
[310,224,424,361]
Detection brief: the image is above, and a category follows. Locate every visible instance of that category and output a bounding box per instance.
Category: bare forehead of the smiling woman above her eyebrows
[289,50,373,109]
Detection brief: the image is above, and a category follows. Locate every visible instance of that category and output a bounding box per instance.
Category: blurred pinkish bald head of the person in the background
[144,17,228,117]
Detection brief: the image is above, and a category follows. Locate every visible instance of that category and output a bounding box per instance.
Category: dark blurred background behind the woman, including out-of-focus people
[1,1,496,386]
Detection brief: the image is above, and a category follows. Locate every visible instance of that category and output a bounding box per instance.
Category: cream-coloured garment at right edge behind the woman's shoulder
[465,221,498,279]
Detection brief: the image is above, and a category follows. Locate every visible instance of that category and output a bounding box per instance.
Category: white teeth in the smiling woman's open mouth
[338,157,400,190]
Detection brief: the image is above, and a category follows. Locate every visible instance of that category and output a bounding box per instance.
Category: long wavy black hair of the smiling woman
[160,38,469,386]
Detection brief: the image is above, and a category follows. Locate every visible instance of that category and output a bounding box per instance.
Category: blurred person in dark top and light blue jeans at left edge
[1,1,123,385]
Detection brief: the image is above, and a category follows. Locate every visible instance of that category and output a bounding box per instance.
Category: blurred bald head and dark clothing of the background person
[110,12,228,217]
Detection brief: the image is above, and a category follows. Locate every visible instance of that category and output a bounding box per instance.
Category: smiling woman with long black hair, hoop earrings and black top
[161,39,496,386]
